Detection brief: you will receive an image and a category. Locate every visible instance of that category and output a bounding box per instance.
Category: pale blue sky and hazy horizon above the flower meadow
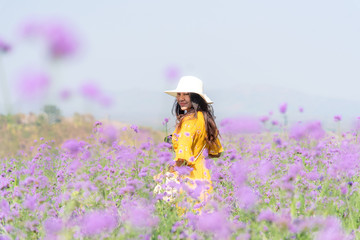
[0,0,360,129]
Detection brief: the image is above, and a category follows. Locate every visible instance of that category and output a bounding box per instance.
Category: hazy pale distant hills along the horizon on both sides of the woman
[3,85,360,130]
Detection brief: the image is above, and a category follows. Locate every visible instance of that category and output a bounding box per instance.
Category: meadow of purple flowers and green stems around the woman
[0,113,360,239]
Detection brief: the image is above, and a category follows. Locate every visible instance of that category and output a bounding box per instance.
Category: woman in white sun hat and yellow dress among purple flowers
[165,76,224,201]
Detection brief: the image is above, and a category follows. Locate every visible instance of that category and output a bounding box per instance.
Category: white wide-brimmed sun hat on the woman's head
[165,76,213,104]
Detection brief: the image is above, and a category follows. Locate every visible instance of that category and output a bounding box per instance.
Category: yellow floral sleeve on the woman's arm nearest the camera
[173,117,196,165]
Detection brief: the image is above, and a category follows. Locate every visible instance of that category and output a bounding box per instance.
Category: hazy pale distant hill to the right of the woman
[209,83,360,128]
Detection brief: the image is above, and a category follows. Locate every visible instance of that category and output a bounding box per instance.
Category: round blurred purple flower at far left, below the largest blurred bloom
[17,72,50,99]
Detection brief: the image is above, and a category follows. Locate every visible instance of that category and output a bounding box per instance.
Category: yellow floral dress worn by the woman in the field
[172,111,224,201]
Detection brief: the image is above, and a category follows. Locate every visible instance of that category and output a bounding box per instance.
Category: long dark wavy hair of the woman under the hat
[172,93,219,146]
